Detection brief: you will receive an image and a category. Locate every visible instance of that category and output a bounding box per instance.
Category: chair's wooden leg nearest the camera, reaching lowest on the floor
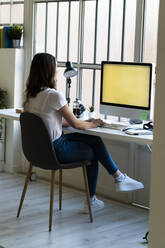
[49,170,56,232]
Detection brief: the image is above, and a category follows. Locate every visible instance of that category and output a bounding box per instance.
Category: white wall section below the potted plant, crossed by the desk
[0,48,24,172]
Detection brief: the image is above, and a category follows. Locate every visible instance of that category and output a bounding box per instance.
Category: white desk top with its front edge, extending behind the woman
[0,109,153,145]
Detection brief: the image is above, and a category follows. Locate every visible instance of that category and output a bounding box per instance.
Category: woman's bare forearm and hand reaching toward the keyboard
[59,105,104,130]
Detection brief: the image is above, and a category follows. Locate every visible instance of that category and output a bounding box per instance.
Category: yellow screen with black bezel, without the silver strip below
[101,62,152,109]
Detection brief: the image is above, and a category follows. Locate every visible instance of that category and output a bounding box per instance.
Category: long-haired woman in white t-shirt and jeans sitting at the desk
[24,53,143,210]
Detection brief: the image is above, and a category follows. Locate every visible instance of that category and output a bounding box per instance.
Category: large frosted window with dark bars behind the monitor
[33,0,159,118]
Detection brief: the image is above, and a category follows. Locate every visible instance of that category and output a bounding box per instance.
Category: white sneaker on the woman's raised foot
[116,174,144,192]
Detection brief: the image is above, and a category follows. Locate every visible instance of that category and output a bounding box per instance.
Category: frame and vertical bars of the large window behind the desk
[24,0,159,116]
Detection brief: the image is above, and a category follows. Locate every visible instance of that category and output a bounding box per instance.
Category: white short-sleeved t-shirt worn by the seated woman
[25,88,67,141]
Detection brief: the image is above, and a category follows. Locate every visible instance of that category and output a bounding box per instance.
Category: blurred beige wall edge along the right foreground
[149,0,165,248]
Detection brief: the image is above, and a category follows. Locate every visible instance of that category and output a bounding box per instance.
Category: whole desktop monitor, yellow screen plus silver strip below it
[100,61,152,119]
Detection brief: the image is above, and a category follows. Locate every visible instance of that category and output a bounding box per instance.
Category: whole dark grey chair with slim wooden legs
[17,112,93,231]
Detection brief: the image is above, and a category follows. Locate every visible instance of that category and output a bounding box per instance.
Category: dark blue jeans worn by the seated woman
[53,133,118,196]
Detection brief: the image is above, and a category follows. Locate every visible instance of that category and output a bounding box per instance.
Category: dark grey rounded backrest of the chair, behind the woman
[20,112,60,169]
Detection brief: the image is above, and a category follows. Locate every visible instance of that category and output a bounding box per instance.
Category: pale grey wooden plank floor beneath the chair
[0,173,148,248]
